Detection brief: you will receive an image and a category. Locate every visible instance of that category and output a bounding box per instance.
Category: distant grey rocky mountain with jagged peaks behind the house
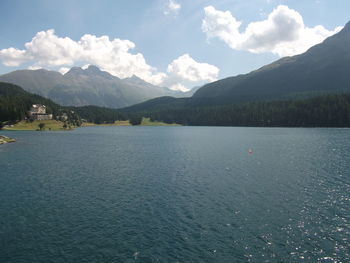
[0,66,189,108]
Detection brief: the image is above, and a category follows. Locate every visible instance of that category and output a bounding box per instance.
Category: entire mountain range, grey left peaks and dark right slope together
[0,19,350,112]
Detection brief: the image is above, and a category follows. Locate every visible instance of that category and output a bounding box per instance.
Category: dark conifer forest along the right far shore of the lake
[144,94,350,127]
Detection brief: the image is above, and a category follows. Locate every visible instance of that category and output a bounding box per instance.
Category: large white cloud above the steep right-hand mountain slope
[202,5,342,57]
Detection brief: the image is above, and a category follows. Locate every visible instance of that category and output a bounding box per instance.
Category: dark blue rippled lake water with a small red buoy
[0,127,350,263]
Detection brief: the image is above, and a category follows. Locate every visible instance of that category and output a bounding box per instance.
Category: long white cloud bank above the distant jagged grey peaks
[0,29,219,90]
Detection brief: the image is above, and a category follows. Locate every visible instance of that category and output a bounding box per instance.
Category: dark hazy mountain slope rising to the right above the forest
[124,22,350,112]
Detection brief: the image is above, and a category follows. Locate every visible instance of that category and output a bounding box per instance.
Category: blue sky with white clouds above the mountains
[0,0,350,91]
